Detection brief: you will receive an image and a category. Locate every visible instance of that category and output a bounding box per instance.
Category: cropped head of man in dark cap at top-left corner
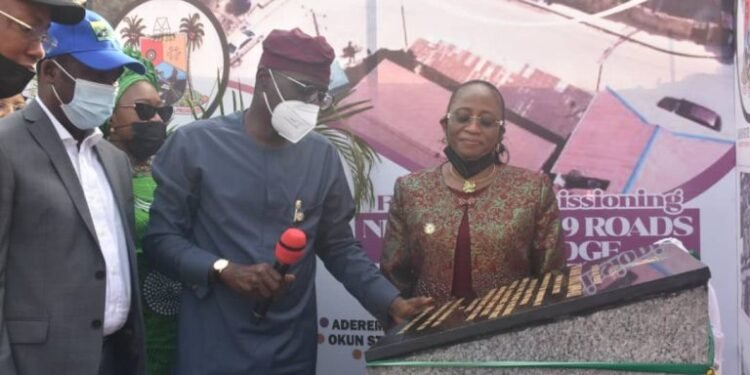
[0,0,85,99]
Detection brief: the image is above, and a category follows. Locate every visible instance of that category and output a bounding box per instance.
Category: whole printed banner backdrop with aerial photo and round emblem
[90,0,750,374]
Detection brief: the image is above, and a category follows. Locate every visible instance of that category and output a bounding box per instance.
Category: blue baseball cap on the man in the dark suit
[45,10,146,74]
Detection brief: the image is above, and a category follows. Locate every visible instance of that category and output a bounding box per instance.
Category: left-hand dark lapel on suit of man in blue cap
[23,99,99,244]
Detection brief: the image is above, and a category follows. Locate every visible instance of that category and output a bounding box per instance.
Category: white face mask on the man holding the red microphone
[263,69,320,143]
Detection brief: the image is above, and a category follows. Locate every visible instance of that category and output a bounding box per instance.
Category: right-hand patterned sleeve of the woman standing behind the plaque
[531,175,565,275]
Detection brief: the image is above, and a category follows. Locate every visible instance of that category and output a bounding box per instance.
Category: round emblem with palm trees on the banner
[92,0,229,127]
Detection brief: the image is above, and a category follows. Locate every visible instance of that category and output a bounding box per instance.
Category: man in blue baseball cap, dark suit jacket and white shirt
[0,11,145,375]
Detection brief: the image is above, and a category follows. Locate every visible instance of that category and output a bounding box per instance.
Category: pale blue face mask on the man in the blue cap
[52,60,117,130]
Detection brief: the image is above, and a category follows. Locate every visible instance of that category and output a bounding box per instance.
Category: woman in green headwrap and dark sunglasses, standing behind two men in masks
[102,50,181,375]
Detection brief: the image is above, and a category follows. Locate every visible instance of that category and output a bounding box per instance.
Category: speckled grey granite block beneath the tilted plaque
[367,287,713,375]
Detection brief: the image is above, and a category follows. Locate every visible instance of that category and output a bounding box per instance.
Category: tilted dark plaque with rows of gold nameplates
[365,242,710,362]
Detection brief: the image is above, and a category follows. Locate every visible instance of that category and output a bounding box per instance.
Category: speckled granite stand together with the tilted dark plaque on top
[365,242,713,375]
